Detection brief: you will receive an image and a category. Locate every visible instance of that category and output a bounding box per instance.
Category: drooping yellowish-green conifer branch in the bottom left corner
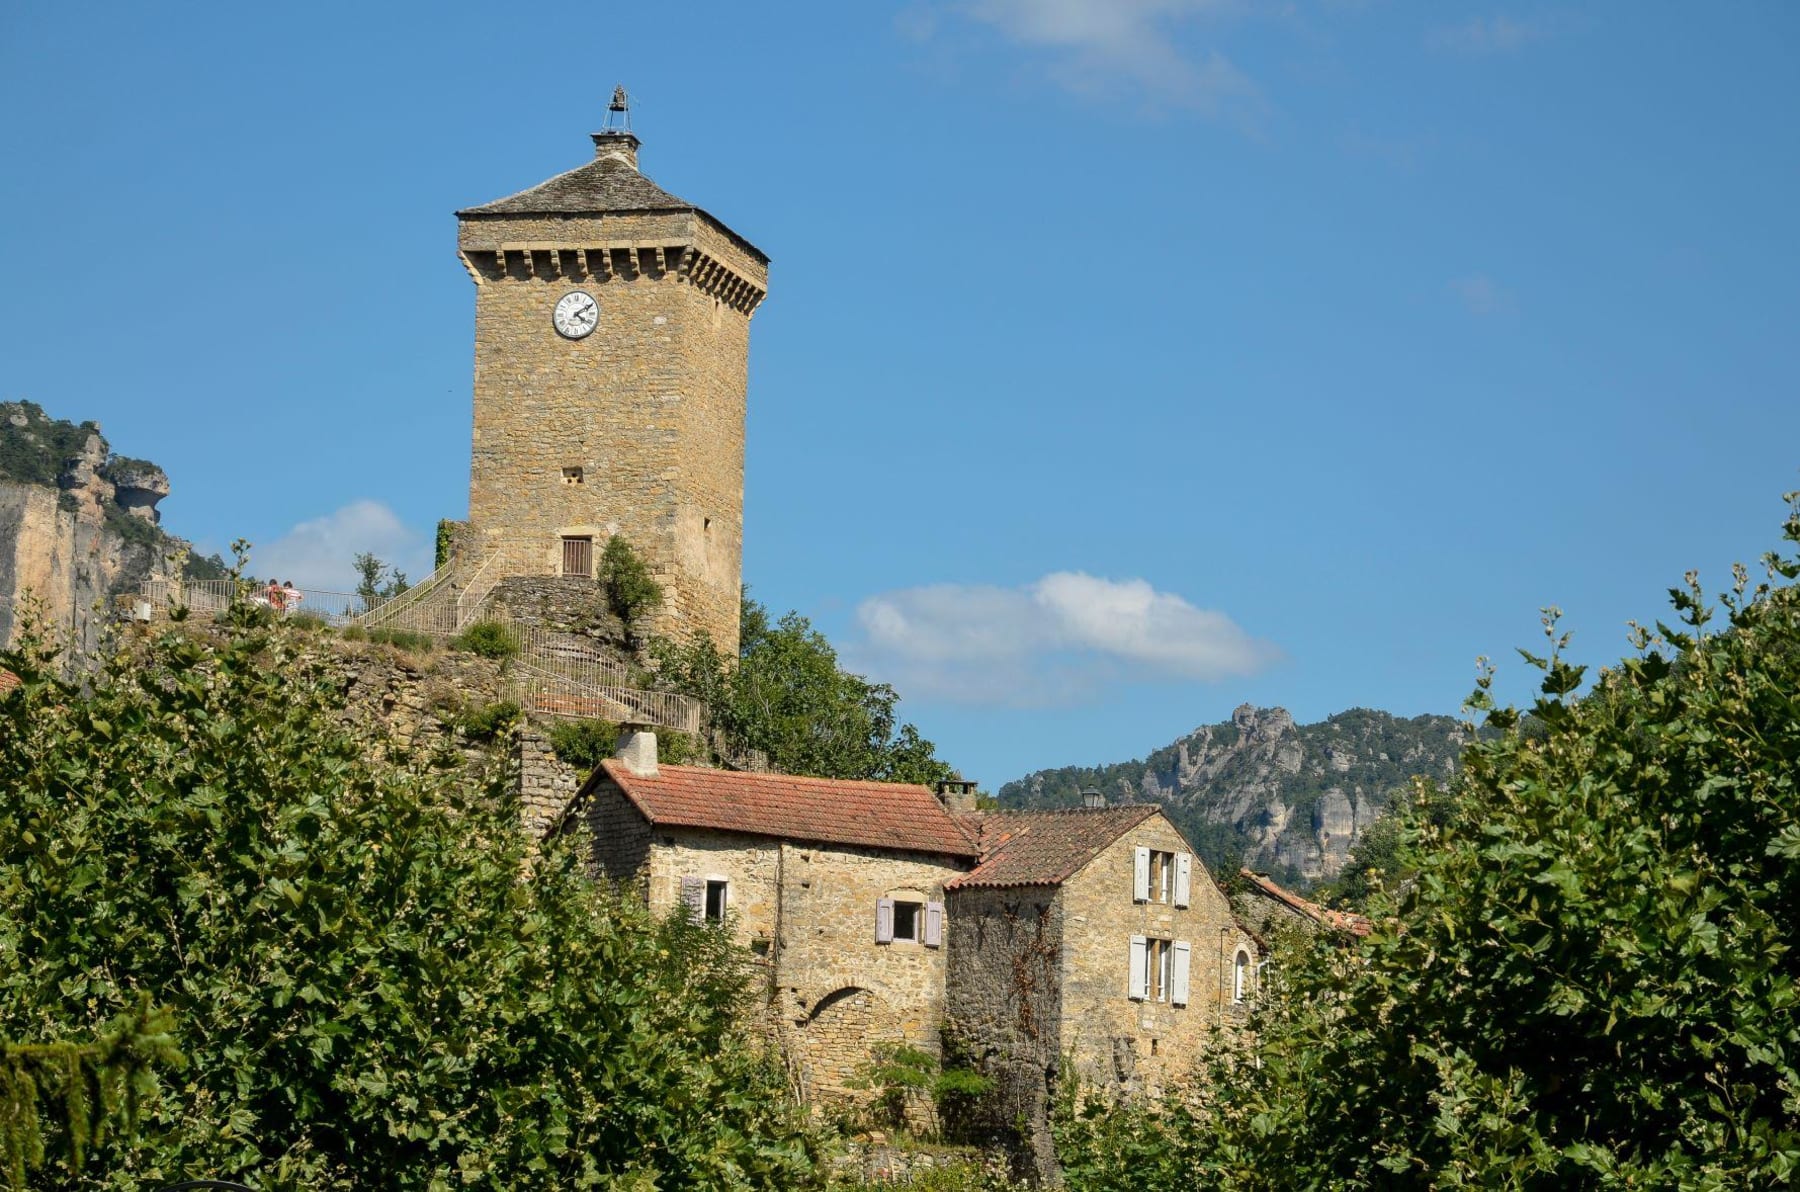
[0,998,185,1188]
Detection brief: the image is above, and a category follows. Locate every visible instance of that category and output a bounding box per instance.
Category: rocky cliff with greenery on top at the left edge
[0,402,219,652]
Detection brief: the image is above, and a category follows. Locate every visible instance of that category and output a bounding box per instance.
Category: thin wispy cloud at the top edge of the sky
[904,0,1262,118]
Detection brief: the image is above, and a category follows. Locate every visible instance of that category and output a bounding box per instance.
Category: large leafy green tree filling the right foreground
[1058,497,1800,1188]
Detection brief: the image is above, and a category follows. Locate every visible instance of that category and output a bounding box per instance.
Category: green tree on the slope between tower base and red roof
[652,596,952,783]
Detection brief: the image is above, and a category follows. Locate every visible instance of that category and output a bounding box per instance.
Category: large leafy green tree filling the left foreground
[0,618,812,1188]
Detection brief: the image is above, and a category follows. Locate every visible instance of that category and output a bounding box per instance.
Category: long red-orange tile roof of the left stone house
[581,760,976,859]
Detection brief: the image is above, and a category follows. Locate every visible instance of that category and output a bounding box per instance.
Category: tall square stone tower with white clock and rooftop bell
[457,88,769,654]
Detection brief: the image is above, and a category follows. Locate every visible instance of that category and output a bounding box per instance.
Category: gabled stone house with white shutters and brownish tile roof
[945,805,1260,1172]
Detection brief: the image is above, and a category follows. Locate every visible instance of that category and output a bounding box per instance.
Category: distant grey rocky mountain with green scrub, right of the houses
[999,704,1463,886]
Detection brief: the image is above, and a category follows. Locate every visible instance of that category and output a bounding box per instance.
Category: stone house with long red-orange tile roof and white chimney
[558,733,977,1102]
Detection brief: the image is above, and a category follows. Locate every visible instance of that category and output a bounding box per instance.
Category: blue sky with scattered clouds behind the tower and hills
[0,0,1800,785]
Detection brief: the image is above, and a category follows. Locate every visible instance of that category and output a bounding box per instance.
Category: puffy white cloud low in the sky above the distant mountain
[850,571,1278,706]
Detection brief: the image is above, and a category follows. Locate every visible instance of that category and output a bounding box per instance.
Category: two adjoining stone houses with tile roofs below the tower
[549,731,1260,1172]
